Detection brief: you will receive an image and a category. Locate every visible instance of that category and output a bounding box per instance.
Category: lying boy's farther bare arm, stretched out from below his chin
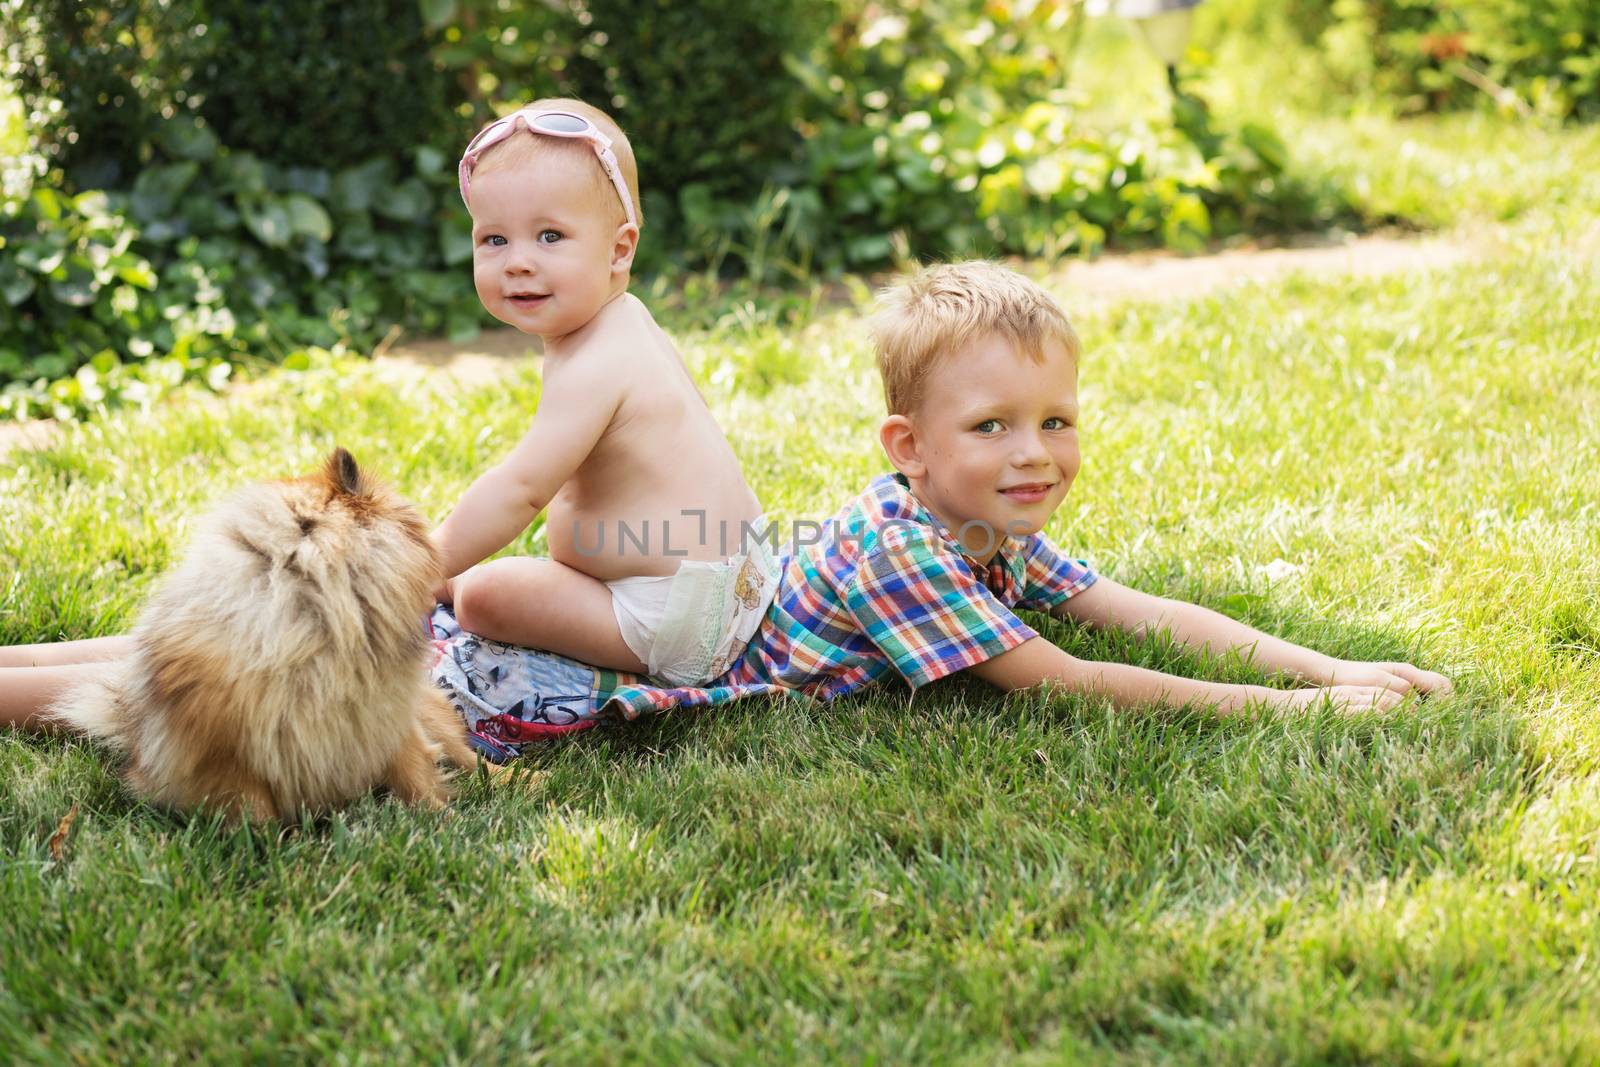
[1054,577,1450,693]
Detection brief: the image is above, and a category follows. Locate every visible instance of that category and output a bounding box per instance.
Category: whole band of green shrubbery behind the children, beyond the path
[0,0,1350,413]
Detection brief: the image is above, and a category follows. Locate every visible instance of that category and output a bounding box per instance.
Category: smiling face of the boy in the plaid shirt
[885,336,1078,563]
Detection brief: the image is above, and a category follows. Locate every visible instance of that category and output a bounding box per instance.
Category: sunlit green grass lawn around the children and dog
[9,112,1600,1064]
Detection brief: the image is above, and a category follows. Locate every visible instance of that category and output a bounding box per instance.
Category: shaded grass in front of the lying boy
[480,585,1539,910]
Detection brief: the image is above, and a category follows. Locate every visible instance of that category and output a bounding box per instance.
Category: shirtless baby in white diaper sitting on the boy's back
[435,99,776,685]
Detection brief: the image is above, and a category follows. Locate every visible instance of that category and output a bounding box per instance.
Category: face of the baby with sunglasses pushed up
[472,155,627,341]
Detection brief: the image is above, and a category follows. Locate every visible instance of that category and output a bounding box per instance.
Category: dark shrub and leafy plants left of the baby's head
[0,0,482,414]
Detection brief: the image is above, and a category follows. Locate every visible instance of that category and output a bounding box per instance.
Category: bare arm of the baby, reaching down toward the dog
[434,358,626,579]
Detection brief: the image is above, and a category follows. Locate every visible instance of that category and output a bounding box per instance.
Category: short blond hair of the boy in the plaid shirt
[872,259,1078,414]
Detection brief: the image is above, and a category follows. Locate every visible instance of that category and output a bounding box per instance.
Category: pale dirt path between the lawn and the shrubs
[0,234,1472,459]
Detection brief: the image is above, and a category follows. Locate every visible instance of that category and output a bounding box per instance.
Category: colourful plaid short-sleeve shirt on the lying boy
[597,474,1096,718]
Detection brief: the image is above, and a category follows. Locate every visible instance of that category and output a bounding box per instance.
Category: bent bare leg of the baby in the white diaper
[451,557,645,673]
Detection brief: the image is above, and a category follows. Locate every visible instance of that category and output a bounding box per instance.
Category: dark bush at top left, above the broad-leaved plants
[0,0,466,182]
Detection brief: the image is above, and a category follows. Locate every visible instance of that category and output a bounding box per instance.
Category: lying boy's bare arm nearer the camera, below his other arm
[971,639,1403,713]
